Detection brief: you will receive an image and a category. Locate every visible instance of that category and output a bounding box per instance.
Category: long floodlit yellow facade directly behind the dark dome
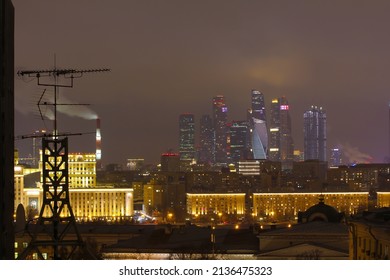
[252,192,368,221]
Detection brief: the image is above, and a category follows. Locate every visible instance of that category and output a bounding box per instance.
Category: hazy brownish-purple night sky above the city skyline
[12,0,390,164]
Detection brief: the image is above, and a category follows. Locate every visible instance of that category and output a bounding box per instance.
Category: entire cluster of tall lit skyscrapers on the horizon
[179,90,327,169]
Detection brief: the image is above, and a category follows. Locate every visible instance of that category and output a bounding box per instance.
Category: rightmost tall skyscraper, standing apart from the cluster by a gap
[303,106,326,161]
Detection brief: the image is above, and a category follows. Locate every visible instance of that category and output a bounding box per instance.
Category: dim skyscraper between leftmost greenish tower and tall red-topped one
[198,115,214,163]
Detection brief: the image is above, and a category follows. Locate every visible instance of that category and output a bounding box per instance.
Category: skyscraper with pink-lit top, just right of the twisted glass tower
[269,97,294,169]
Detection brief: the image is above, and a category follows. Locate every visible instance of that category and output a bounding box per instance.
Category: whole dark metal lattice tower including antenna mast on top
[18,66,109,259]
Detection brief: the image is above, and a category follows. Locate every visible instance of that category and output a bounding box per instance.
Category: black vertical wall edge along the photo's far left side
[0,0,15,260]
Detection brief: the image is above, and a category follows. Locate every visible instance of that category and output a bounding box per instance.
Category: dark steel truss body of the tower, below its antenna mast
[20,137,84,259]
